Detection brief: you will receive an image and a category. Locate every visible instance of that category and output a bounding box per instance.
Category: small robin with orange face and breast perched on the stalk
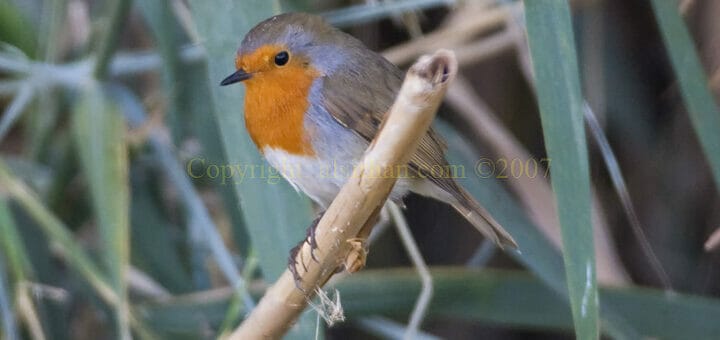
[221,13,517,251]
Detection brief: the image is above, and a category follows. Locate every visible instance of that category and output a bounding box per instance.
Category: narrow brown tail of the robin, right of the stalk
[448,186,518,249]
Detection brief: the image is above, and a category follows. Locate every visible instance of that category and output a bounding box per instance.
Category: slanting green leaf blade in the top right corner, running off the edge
[651,0,720,190]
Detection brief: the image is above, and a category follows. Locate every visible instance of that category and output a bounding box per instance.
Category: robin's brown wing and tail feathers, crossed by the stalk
[322,50,517,248]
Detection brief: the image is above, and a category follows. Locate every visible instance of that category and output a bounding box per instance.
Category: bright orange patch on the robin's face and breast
[245,65,316,155]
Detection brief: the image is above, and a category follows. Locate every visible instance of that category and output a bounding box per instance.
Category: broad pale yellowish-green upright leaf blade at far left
[73,84,131,339]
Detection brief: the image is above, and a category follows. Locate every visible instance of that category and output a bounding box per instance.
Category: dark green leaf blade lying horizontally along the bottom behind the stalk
[139,267,720,339]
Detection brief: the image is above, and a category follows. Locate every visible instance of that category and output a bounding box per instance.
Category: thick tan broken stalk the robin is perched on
[230,50,457,339]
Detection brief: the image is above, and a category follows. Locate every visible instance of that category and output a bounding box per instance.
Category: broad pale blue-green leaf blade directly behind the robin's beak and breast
[184,0,315,338]
